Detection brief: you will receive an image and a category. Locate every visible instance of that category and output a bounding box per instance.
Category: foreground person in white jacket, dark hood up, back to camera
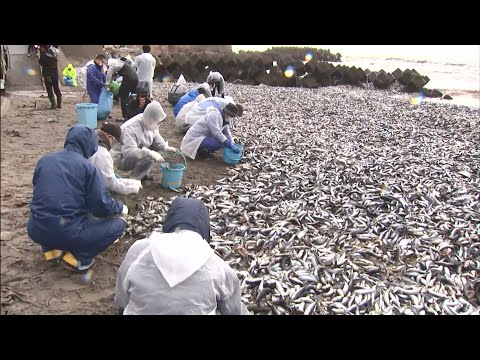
[115,197,248,315]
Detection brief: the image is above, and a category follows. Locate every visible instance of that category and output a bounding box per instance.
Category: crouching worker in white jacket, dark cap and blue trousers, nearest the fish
[180,103,240,159]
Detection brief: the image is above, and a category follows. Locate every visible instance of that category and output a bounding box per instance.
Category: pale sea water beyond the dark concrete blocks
[340,56,480,107]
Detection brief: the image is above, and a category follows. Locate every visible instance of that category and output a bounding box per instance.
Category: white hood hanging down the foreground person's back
[149,230,213,287]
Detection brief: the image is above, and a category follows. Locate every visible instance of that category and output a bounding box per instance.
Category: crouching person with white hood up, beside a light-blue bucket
[110,101,178,180]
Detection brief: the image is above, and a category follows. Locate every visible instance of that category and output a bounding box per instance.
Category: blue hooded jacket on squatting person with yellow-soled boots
[28,125,123,248]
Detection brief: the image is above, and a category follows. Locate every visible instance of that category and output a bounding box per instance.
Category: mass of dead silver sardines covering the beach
[129,84,480,315]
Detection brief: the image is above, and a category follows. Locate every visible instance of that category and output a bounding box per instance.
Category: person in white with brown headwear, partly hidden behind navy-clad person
[89,122,142,195]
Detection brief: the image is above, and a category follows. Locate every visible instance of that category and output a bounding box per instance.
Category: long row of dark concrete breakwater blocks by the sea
[157,53,442,97]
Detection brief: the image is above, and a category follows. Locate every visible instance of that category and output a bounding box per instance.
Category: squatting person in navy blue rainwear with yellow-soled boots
[27,124,128,272]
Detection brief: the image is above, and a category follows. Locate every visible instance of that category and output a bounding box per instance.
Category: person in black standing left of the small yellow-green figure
[38,45,62,109]
